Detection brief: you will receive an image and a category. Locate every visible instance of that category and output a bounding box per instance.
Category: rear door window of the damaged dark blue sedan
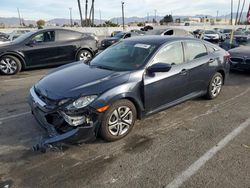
[186,42,208,61]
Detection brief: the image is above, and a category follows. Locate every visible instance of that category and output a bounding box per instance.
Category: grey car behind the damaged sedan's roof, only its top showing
[146,28,194,37]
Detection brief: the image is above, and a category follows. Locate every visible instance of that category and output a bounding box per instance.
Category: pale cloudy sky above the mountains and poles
[0,0,250,20]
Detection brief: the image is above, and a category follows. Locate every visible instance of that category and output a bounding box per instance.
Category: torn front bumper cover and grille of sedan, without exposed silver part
[28,88,100,150]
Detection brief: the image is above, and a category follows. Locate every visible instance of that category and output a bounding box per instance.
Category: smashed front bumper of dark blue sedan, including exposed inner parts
[28,87,100,151]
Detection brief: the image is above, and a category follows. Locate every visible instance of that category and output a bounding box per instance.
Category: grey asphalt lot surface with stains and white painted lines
[0,69,250,188]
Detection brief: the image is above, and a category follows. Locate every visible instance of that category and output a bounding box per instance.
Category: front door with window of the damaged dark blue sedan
[144,42,188,112]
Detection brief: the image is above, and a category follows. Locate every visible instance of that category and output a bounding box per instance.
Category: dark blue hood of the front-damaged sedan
[35,62,130,100]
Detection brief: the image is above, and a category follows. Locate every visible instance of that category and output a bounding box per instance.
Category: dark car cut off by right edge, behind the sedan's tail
[229,46,250,71]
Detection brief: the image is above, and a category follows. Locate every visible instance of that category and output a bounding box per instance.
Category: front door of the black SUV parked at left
[23,30,58,66]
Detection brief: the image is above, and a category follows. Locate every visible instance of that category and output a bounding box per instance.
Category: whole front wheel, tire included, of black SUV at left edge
[0,55,22,75]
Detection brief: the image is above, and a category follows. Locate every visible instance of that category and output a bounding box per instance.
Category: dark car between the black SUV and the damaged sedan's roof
[101,32,139,49]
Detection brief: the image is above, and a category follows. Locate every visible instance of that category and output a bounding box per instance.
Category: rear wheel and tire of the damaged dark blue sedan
[206,72,223,99]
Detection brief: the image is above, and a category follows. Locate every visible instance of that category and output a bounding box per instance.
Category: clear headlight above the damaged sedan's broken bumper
[66,95,97,110]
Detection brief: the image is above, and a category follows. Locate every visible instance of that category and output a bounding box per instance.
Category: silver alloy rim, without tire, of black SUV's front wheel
[0,57,18,74]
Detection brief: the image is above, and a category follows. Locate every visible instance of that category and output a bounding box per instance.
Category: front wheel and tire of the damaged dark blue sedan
[100,99,137,142]
